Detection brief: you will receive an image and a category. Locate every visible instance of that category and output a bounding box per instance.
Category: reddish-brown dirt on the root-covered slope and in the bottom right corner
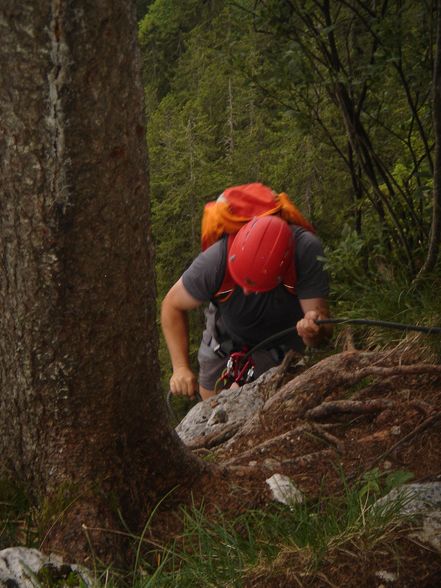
[155,353,441,588]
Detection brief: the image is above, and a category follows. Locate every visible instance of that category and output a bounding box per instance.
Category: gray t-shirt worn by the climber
[182,226,329,351]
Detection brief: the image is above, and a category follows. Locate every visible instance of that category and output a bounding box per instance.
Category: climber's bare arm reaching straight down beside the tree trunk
[161,278,202,397]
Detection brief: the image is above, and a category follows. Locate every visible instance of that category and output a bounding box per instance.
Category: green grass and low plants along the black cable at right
[325,233,441,358]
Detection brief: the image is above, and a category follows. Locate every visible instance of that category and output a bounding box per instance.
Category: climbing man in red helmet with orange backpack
[161,183,332,399]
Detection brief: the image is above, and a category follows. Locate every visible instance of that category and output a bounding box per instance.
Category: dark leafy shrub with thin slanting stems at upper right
[249,1,433,275]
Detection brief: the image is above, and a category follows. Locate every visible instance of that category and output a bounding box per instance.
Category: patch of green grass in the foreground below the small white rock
[132,470,410,588]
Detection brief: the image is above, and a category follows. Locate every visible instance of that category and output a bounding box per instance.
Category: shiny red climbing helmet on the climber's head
[228,216,293,292]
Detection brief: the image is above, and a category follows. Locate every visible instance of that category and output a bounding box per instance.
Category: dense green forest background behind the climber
[138,0,441,386]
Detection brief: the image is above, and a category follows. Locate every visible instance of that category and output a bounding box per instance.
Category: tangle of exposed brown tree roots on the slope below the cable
[185,352,441,512]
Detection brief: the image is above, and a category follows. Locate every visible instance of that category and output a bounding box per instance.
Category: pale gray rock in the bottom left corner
[0,547,92,588]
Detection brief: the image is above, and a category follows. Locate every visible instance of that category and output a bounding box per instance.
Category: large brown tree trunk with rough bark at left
[0,0,201,555]
